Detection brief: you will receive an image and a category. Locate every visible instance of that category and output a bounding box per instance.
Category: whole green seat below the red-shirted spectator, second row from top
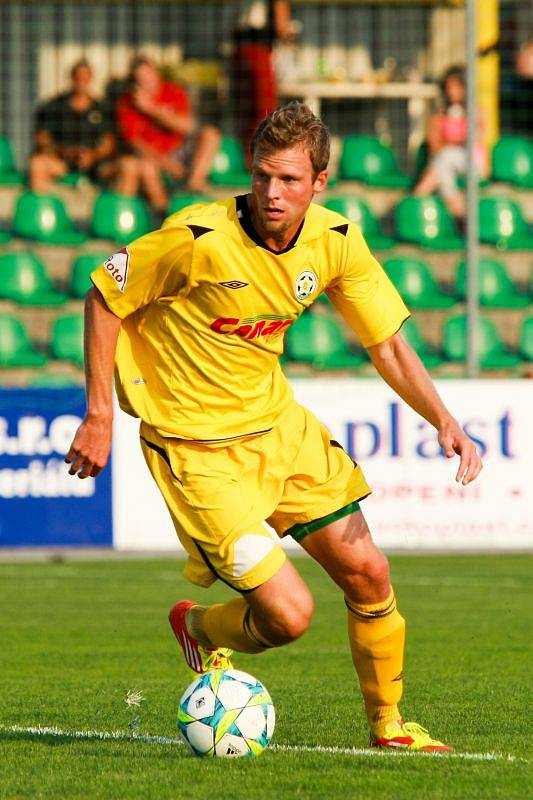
[91,192,153,245]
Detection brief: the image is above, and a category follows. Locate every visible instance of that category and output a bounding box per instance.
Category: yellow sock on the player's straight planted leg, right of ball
[346,590,405,736]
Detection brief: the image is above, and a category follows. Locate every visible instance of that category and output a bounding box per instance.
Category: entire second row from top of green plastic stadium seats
[0,192,533,251]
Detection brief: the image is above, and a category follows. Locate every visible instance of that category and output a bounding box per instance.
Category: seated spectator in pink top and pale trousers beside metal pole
[414,66,489,220]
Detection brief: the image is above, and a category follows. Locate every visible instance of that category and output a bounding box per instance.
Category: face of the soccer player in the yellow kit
[251,147,328,246]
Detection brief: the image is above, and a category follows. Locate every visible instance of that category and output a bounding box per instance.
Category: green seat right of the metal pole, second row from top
[479,197,533,250]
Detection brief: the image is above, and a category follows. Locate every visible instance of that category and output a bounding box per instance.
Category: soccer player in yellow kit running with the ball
[66,103,481,752]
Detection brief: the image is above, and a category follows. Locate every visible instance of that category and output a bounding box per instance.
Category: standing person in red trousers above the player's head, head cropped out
[232,0,295,157]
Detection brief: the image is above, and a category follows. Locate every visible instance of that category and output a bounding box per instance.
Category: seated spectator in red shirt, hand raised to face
[116,57,220,212]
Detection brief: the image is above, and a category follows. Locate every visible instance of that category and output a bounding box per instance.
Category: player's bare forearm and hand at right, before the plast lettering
[368,333,483,486]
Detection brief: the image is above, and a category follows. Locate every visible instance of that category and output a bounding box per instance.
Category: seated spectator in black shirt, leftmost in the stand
[30,61,116,192]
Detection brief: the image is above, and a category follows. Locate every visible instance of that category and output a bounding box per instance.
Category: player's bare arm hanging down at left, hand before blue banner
[65,288,122,478]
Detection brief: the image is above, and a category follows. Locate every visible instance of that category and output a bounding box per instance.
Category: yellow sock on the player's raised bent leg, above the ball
[186,597,273,653]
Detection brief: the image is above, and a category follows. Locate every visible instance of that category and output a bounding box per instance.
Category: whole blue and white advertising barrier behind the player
[0,378,533,551]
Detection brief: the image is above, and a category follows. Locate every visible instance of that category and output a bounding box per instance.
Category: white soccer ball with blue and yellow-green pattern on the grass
[178,669,276,758]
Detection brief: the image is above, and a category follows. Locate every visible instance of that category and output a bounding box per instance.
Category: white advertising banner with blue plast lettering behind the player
[113,378,533,550]
